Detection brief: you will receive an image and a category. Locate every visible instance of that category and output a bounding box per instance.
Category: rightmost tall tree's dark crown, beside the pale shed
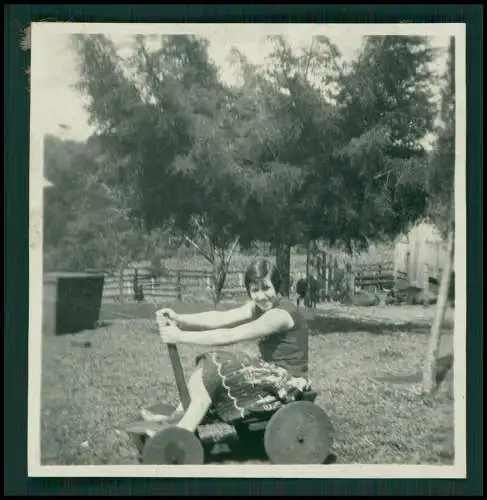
[308,36,442,251]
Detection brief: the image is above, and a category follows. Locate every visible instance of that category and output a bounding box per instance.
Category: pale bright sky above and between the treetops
[32,23,449,144]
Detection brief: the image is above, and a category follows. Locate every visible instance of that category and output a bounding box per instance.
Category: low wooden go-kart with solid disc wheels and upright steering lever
[125,336,334,465]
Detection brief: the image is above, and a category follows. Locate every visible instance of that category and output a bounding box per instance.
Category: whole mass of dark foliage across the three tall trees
[66,35,446,292]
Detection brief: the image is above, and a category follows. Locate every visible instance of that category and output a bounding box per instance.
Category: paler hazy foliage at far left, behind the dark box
[44,136,177,271]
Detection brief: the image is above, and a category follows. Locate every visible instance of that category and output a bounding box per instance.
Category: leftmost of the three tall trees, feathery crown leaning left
[72,35,258,301]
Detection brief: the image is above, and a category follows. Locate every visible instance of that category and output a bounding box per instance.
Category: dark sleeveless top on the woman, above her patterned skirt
[255,298,309,378]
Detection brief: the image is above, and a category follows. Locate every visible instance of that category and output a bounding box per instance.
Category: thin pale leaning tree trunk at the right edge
[423,230,454,393]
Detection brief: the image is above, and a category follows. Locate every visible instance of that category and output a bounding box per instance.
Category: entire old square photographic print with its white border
[28,22,466,478]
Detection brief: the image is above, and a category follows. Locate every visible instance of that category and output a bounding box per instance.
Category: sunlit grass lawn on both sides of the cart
[41,305,454,465]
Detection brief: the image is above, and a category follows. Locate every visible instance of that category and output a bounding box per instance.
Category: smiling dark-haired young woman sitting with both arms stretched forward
[143,259,310,432]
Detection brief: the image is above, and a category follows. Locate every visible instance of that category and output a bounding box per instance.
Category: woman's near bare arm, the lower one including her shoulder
[180,309,294,346]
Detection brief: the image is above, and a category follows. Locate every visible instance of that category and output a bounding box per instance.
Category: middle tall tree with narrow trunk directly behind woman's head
[230,36,346,294]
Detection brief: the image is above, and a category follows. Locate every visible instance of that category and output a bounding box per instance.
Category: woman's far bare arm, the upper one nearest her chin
[177,302,253,331]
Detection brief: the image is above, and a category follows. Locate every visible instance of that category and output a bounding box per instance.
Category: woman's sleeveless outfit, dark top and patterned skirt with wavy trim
[196,299,310,423]
